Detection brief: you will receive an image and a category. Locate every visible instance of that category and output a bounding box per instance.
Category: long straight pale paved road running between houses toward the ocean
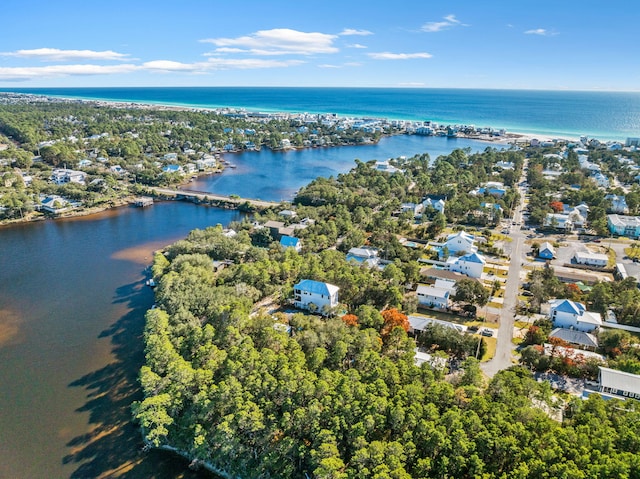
[482,161,527,377]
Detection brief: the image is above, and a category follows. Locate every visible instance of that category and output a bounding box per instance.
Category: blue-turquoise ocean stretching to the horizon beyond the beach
[4,87,640,140]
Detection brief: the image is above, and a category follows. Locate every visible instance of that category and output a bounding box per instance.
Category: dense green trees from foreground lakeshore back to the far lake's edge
[133,146,640,479]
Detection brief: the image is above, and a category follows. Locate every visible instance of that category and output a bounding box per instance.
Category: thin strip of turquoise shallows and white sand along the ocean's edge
[0,91,604,144]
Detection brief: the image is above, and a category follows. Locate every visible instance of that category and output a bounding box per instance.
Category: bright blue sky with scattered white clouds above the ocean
[0,0,640,91]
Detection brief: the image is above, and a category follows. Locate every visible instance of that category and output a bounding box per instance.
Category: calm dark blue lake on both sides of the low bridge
[0,136,488,478]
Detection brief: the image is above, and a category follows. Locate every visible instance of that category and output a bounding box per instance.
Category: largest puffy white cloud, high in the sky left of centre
[200,28,338,55]
